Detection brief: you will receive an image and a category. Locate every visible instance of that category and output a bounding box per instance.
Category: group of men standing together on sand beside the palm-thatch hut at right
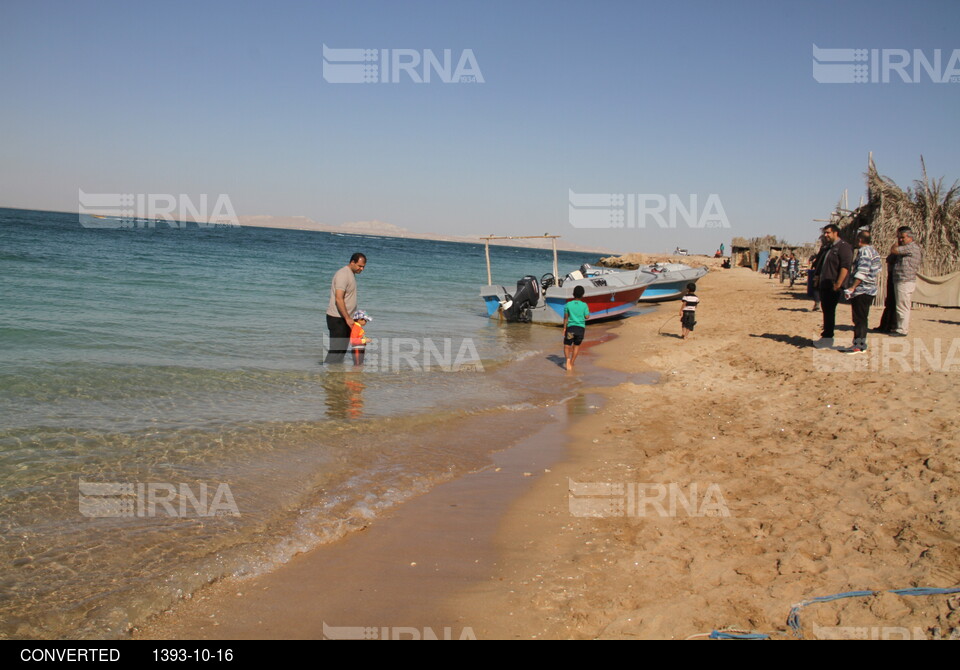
[811,223,923,354]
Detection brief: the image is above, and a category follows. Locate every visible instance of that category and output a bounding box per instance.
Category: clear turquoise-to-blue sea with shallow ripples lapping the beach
[0,209,644,639]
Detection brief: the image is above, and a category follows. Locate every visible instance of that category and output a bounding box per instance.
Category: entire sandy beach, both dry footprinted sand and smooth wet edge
[134,269,960,639]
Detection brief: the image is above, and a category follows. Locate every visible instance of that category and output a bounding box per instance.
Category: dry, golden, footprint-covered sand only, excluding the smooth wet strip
[452,269,960,639]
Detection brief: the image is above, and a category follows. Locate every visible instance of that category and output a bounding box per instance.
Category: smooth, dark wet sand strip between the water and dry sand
[132,324,649,639]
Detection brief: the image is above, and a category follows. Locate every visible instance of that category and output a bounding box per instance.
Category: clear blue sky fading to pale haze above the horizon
[0,0,960,253]
